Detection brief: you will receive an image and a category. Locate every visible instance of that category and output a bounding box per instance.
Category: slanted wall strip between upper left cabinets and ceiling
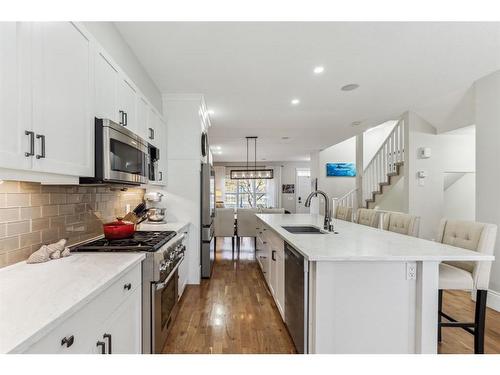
[83,22,163,113]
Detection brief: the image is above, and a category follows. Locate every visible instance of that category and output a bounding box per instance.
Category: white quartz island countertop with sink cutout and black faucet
[257,214,495,261]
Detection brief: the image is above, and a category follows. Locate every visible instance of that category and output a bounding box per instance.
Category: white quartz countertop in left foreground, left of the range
[0,253,145,353]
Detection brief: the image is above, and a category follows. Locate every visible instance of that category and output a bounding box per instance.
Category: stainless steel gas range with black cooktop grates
[72,231,186,353]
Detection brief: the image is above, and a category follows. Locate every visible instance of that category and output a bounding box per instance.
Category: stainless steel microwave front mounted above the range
[102,120,149,184]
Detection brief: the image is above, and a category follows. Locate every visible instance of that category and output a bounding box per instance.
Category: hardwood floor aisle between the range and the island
[163,238,295,354]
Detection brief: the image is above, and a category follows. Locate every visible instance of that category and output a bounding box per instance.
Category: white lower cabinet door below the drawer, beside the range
[93,287,142,354]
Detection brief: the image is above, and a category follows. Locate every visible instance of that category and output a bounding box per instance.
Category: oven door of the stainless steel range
[152,268,179,353]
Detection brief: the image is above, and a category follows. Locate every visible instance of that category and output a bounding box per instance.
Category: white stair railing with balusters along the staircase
[362,119,405,202]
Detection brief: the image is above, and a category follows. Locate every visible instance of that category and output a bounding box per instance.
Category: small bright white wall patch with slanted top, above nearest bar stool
[443,173,476,221]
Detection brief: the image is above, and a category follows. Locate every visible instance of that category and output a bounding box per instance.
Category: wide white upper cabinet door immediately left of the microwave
[33,22,94,176]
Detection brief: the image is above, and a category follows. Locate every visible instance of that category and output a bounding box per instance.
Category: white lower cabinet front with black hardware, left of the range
[24,264,142,354]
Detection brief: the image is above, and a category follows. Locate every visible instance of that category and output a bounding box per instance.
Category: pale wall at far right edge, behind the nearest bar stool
[475,70,500,300]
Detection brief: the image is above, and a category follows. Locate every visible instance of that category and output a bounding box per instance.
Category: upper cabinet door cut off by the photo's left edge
[0,22,32,169]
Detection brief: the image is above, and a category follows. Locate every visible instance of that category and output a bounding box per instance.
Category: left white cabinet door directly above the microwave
[94,51,121,123]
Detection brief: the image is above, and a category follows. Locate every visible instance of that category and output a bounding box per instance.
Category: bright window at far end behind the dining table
[224,175,269,208]
